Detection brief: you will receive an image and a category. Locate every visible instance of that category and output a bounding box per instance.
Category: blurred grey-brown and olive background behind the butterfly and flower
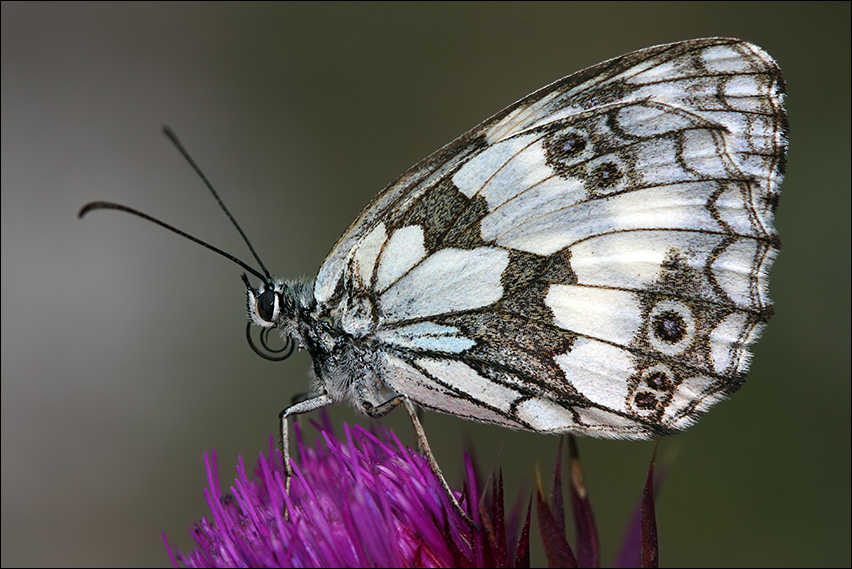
[0,2,850,567]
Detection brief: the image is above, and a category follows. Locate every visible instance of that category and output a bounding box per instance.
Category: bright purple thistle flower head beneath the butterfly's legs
[164,414,530,567]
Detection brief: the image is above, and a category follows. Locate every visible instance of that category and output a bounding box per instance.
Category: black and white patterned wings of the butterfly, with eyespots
[313,38,787,438]
